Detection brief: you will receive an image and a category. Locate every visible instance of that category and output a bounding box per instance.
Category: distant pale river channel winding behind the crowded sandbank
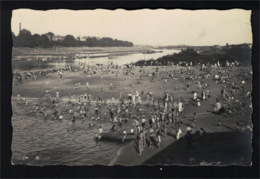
[12,49,179,71]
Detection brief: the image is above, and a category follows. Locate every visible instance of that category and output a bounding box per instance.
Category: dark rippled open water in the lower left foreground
[12,109,124,165]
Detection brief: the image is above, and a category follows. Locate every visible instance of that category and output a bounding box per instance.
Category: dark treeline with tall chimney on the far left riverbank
[12,29,134,48]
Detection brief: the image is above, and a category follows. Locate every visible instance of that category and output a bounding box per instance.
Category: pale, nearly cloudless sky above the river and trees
[11,9,252,46]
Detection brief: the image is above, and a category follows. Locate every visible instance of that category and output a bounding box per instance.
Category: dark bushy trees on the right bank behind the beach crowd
[136,44,251,66]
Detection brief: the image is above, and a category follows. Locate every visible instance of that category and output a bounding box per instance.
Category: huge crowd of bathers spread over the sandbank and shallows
[12,59,252,155]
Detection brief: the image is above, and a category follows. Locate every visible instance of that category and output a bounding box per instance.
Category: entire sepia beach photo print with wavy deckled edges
[11,9,253,166]
